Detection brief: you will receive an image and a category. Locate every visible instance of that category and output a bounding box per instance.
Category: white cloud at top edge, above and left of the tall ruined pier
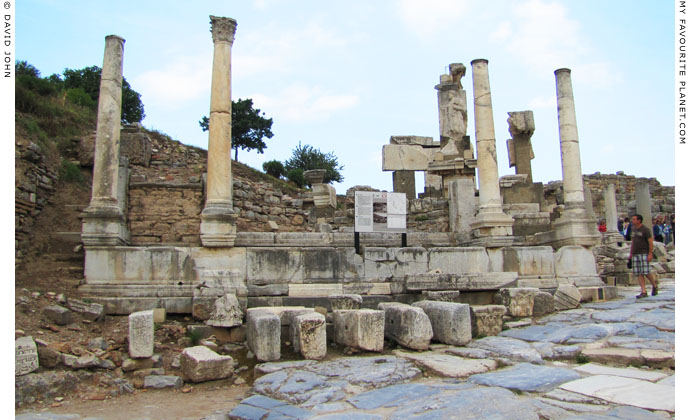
[398,0,468,38]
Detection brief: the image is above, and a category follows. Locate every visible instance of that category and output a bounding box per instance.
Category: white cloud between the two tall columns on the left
[132,56,212,109]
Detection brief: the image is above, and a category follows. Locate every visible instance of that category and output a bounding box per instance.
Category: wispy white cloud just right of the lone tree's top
[250,84,359,122]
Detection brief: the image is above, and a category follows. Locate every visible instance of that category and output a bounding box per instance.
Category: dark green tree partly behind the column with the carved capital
[199,99,273,162]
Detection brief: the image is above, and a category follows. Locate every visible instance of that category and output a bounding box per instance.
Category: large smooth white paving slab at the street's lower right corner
[560,375,676,412]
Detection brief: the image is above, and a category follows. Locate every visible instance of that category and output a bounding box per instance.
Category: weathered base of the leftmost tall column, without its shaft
[81,205,129,247]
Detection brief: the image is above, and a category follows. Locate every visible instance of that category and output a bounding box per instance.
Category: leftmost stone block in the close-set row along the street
[247,308,280,362]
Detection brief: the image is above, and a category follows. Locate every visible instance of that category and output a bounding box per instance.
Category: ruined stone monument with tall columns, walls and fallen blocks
[35,16,664,364]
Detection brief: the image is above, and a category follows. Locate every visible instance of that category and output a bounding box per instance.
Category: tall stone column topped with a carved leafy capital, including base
[201,16,237,247]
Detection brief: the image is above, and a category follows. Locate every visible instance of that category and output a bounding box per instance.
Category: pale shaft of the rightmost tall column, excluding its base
[555,68,585,213]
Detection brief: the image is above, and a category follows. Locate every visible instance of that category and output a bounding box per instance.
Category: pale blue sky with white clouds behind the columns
[16,0,675,194]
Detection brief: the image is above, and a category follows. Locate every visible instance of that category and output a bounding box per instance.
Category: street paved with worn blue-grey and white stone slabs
[15,279,675,420]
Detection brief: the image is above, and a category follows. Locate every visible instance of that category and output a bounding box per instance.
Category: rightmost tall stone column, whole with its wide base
[554,68,600,247]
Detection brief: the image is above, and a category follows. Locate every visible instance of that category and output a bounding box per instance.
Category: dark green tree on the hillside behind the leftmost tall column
[62,66,146,123]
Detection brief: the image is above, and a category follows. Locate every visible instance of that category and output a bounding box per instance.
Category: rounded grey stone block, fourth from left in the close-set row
[378,302,434,350]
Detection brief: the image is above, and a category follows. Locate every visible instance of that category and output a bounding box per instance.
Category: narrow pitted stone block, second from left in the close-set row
[290,312,327,360]
